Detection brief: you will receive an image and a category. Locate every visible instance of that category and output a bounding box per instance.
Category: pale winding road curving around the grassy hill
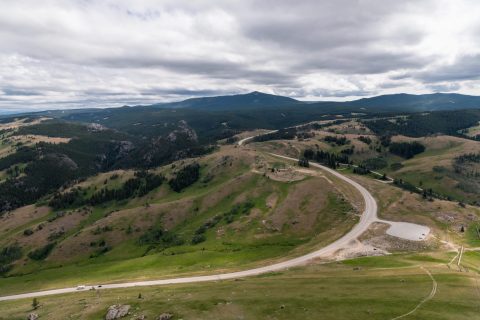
[0,132,426,301]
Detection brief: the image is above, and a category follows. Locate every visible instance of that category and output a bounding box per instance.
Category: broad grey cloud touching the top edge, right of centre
[243,0,428,51]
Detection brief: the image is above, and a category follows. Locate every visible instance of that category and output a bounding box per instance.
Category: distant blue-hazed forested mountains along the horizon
[5,91,480,125]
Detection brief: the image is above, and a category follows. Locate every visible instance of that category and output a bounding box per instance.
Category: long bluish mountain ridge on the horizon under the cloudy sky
[0,91,480,119]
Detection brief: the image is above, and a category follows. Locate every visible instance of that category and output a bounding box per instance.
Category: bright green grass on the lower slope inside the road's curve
[0,171,356,293]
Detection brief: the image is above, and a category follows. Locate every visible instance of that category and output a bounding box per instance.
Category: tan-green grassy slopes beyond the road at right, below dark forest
[252,129,480,203]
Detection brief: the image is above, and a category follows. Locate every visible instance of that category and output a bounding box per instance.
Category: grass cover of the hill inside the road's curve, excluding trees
[0,146,357,294]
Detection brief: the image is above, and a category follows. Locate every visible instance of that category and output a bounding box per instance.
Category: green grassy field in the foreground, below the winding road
[0,253,480,320]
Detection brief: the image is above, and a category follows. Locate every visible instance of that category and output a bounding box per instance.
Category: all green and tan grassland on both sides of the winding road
[0,122,480,320]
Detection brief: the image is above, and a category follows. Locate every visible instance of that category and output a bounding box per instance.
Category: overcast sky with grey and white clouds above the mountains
[0,0,480,113]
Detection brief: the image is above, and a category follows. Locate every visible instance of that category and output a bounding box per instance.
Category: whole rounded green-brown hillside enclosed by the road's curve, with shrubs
[0,146,358,292]
